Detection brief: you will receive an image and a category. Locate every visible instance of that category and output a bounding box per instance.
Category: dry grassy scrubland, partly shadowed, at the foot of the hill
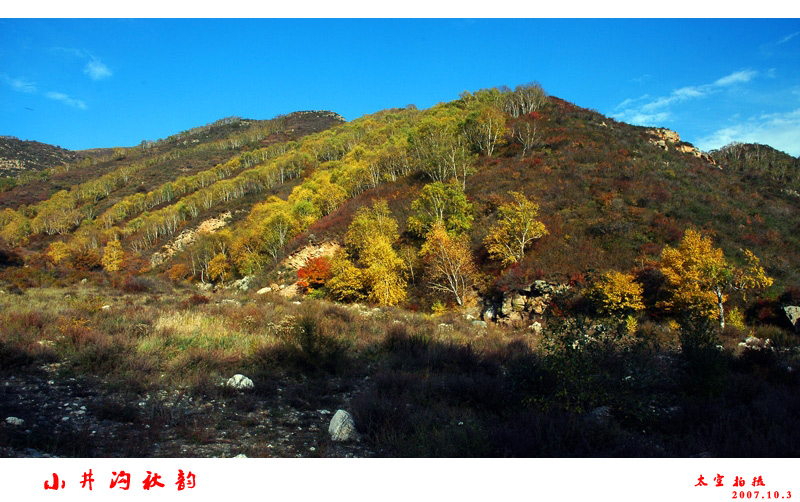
[0,282,800,457]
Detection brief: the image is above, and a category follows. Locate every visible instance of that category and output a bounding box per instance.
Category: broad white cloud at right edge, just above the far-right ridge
[696,108,800,157]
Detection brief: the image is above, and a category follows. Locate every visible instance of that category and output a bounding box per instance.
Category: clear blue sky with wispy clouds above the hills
[0,17,800,156]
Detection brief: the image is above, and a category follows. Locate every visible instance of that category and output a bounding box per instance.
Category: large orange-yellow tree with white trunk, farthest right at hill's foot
[661,229,772,329]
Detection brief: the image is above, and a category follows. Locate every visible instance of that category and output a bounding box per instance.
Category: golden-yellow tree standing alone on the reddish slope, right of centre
[483,192,548,266]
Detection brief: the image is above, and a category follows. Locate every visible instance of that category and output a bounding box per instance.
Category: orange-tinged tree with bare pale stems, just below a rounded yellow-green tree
[420,222,477,305]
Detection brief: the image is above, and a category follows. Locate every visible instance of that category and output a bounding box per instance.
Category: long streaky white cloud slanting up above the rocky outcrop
[612,70,759,126]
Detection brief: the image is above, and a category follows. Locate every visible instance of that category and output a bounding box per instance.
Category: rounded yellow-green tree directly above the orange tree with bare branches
[408,182,473,237]
